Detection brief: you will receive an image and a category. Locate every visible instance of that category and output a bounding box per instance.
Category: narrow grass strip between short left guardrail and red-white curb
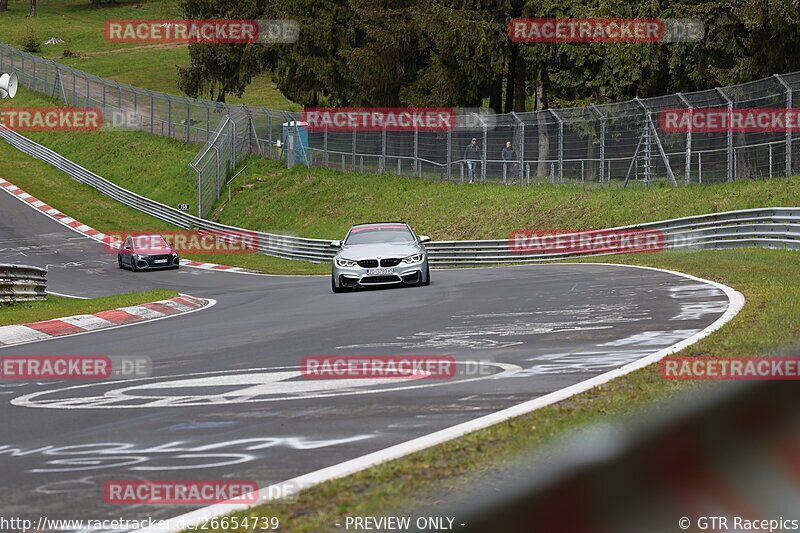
[0,289,178,326]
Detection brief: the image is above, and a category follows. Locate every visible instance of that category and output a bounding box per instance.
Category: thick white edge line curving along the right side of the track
[131,263,745,533]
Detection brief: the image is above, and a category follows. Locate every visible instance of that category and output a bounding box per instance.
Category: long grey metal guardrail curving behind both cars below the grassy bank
[0,127,800,266]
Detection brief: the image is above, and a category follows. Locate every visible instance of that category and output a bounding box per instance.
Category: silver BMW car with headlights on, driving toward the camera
[331,222,431,292]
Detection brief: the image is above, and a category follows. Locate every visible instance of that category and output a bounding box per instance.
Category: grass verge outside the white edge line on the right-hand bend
[184,249,800,533]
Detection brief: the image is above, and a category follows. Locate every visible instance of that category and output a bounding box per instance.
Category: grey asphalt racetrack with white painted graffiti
[0,188,729,519]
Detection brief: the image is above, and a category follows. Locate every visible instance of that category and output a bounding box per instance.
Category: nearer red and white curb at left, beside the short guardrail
[0,294,212,347]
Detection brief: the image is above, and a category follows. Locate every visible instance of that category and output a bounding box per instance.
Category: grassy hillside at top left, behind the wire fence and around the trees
[0,0,301,111]
